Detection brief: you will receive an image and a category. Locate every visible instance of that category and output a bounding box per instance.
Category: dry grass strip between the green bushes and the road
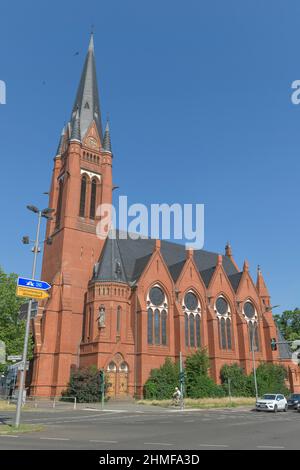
[137,397,255,409]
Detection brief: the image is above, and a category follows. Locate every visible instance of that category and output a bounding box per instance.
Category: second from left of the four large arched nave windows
[182,291,201,348]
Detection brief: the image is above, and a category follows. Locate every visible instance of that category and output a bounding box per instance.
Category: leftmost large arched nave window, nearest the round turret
[147,285,168,346]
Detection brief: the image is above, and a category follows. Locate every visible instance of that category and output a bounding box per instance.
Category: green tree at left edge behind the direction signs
[0,268,33,371]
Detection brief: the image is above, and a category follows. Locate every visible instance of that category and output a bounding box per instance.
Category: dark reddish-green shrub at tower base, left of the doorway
[61,366,101,403]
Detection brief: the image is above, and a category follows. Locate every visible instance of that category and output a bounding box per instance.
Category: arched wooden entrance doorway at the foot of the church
[106,354,128,398]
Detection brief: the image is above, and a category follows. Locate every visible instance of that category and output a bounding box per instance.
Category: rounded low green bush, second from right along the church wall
[220,364,252,397]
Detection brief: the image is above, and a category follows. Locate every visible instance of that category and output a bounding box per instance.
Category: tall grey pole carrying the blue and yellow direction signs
[15,211,42,428]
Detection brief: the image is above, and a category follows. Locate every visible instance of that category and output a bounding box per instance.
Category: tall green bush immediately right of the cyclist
[185,349,224,398]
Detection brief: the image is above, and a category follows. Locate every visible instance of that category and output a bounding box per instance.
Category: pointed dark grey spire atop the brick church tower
[71,33,102,141]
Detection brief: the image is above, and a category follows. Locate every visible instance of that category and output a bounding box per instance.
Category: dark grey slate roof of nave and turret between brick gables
[93,231,238,286]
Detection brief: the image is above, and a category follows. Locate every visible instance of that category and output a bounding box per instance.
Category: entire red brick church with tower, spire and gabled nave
[30,36,300,397]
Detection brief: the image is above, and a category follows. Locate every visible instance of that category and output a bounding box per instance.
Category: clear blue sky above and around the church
[0,0,300,311]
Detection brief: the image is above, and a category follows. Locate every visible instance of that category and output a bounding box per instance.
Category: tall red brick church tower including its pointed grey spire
[30,35,112,396]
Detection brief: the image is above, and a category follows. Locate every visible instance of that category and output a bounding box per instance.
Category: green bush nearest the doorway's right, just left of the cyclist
[144,358,179,400]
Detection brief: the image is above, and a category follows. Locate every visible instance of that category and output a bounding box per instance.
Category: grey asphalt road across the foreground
[0,405,300,452]
